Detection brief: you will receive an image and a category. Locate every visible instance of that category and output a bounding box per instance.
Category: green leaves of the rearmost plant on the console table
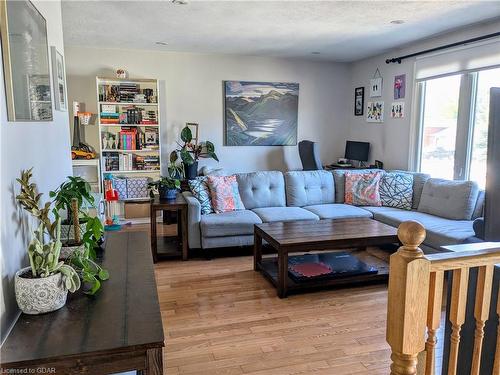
[49,176,94,222]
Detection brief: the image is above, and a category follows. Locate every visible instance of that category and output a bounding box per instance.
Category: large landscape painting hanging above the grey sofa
[224,81,299,146]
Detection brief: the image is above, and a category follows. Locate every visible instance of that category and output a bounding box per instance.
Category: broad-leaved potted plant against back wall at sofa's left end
[170,126,219,180]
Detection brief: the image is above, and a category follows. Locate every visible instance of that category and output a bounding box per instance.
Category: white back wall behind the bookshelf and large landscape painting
[66,45,351,172]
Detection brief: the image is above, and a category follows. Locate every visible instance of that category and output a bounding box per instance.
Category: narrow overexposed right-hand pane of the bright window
[469,68,500,188]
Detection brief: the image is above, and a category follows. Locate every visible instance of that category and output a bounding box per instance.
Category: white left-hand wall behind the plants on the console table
[0,0,71,342]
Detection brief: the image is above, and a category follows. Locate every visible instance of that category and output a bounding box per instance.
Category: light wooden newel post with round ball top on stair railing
[386,221,430,375]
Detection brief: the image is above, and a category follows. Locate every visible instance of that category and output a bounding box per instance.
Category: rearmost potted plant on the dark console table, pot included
[49,176,94,240]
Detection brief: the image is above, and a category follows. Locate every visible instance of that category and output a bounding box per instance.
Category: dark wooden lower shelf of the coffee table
[258,249,389,297]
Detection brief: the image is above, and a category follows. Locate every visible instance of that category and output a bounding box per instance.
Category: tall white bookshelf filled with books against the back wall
[96,77,161,202]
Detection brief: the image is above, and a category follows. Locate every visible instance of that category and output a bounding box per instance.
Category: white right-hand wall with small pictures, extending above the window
[348,21,500,169]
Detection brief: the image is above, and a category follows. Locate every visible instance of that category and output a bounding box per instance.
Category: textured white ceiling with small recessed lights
[62,0,500,61]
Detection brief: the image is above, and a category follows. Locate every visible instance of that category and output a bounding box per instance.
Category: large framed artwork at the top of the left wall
[0,0,52,121]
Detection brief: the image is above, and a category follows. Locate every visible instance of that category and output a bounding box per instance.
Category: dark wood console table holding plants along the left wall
[1,232,164,375]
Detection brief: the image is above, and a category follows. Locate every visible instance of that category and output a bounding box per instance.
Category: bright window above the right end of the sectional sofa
[417,68,500,188]
